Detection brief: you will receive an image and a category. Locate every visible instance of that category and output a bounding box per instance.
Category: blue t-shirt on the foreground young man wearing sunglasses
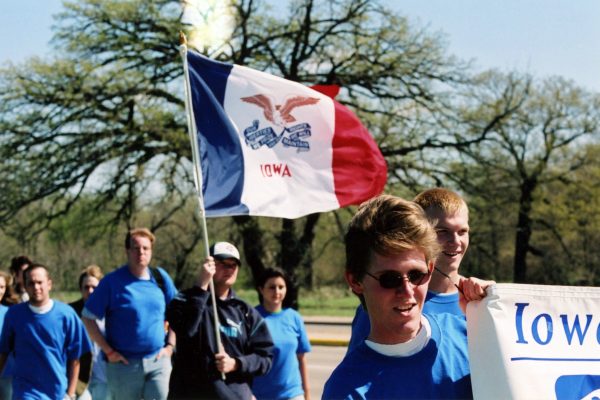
[322,313,473,400]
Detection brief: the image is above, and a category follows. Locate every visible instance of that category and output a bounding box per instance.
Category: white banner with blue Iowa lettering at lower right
[467,284,600,400]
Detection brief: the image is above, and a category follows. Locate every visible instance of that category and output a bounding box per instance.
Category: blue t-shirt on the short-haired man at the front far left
[0,300,91,400]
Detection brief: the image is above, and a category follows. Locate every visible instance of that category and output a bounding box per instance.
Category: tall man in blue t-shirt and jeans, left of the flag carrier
[82,228,177,400]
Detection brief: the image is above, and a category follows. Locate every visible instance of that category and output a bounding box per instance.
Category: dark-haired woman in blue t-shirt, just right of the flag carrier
[252,268,310,400]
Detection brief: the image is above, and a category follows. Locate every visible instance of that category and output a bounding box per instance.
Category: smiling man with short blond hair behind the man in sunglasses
[348,188,469,351]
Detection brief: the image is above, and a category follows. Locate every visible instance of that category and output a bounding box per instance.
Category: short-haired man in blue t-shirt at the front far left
[0,263,91,399]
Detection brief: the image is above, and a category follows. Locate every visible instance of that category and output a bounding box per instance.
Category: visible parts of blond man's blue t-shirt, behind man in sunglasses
[348,291,465,352]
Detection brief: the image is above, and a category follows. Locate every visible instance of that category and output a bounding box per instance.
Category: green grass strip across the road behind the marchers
[56,287,358,317]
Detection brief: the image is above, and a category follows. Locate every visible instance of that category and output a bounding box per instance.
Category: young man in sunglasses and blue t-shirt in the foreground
[323,195,490,399]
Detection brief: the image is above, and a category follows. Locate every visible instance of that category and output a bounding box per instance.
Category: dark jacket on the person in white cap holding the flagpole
[167,286,273,399]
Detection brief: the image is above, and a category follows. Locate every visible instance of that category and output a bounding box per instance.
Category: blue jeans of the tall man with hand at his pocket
[106,355,173,400]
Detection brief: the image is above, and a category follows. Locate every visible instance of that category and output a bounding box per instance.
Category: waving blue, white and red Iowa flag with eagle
[187,51,387,218]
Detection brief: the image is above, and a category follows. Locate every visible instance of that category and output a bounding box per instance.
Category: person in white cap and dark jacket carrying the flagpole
[167,242,273,400]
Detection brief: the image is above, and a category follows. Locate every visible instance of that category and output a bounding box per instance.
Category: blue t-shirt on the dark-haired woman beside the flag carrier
[252,305,310,400]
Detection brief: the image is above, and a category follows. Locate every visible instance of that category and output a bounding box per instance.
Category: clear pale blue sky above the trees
[0,0,600,92]
